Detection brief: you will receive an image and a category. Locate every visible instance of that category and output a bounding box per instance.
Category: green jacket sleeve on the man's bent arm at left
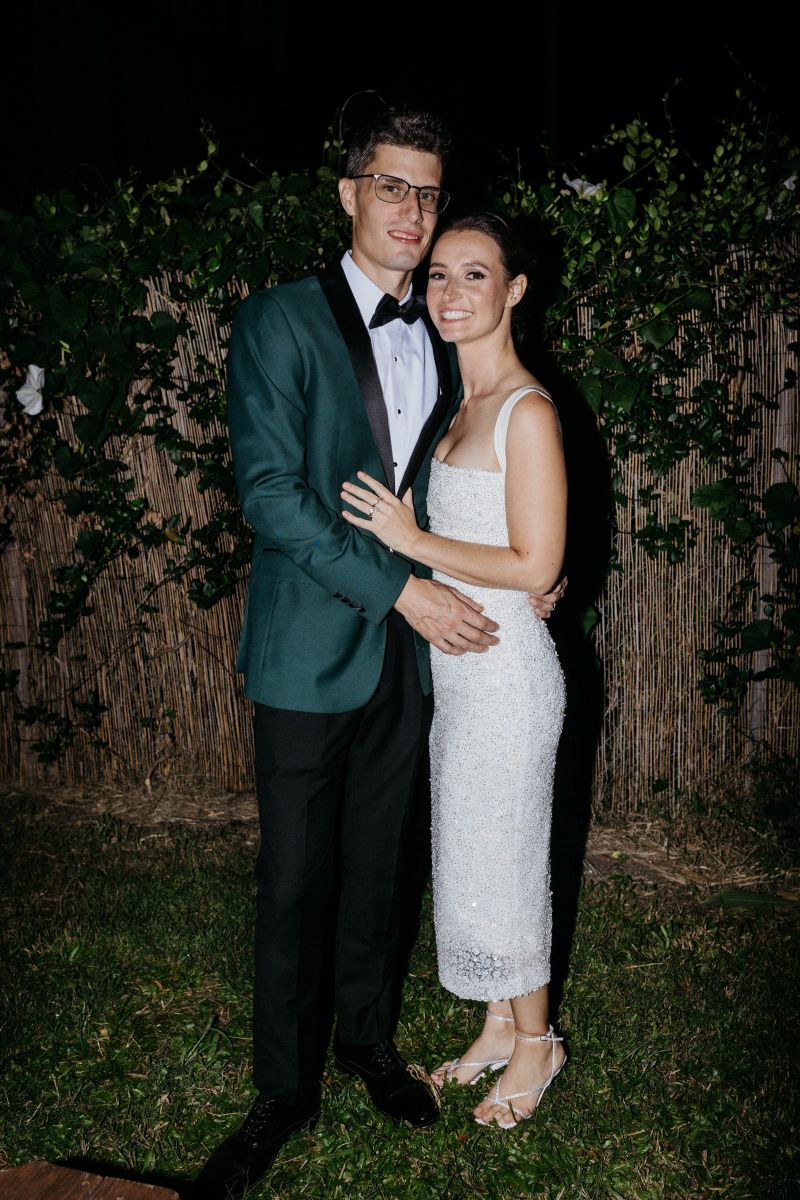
[227,292,411,624]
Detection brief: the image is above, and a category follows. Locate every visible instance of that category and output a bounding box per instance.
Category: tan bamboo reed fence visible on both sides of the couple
[0,270,800,815]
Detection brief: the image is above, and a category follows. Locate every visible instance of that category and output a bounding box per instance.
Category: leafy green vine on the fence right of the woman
[503,102,800,715]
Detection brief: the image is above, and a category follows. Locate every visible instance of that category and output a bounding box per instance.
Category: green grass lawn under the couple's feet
[0,818,800,1200]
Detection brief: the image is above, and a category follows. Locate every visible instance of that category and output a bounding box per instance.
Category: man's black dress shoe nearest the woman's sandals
[333,1040,439,1128]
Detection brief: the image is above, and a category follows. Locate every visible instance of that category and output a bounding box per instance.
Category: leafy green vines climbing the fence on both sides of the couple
[0,100,800,761]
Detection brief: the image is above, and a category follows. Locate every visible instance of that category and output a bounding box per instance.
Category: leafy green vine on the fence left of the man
[0,126,344,761]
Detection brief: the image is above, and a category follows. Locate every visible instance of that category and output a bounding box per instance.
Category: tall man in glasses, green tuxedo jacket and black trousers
[199,113,561,1200]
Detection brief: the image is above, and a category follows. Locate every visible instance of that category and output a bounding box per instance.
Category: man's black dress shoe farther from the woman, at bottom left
[194,1096,319,1200]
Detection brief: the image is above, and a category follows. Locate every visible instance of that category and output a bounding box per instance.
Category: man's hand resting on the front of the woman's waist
[395,575,499,654]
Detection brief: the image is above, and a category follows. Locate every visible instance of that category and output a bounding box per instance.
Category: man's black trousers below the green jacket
[253,612,432,1104]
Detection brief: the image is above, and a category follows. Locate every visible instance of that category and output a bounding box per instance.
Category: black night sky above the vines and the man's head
[0,0,798,205]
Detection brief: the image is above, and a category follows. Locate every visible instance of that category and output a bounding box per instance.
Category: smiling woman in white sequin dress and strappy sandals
[342,214,566,1129]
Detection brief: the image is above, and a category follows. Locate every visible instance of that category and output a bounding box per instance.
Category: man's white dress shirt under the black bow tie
[342,250,439,487]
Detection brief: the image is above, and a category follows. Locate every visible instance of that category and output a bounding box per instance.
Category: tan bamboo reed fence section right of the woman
[578,259,800,816]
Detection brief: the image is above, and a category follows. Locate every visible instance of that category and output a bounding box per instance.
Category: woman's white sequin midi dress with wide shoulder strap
[428,388,565,1000]
